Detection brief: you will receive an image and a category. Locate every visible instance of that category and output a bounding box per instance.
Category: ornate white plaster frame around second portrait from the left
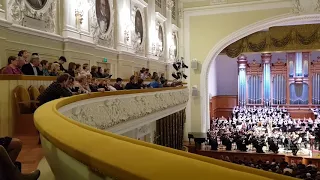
[89,0,115,48]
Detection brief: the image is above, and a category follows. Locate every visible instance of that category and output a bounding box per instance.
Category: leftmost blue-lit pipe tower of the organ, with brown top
[238,54,248,106]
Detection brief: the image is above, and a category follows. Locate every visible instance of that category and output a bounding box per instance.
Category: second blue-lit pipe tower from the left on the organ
[261,53,272,106]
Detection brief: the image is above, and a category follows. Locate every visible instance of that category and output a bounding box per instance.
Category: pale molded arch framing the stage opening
[200,13,320,132]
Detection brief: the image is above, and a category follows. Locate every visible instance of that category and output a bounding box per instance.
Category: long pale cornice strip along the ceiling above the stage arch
[184,0,293,16]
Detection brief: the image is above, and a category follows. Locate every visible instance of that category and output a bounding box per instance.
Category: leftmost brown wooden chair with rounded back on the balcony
[13,85,38,136]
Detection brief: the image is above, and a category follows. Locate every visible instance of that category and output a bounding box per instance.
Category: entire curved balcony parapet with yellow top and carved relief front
[34,87,292,180]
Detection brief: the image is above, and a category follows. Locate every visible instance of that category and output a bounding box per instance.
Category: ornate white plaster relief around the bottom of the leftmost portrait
[8,0,57,33]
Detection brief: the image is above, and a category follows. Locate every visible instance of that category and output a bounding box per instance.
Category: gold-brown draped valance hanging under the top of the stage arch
[222,24,320,58]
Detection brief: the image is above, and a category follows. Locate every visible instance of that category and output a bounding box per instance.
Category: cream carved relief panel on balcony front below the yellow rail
[59,89,189,133]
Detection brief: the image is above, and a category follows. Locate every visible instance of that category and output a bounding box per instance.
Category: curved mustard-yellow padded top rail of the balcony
[34,87,293,180]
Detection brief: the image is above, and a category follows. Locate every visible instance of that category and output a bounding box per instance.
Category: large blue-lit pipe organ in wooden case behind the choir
[238,52,320,106]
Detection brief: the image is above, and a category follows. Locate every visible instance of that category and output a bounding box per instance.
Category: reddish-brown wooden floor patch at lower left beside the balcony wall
[16,136,44,173]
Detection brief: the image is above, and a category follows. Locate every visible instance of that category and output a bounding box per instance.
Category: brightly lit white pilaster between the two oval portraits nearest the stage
[164,0,174,62]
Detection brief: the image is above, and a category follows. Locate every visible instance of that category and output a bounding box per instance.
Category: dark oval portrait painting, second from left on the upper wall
[96,0,110,33]
